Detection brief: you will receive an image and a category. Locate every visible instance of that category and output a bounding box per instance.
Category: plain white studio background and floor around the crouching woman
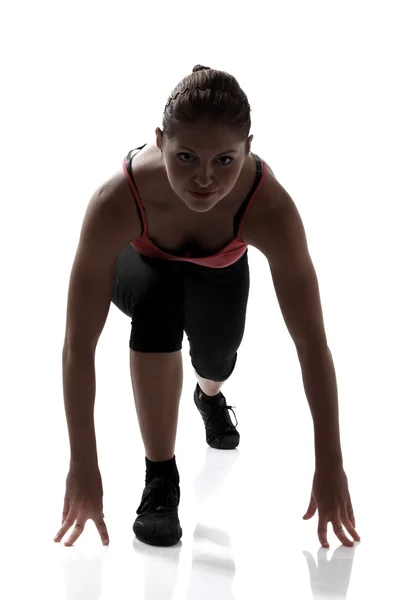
[0,0,400,600]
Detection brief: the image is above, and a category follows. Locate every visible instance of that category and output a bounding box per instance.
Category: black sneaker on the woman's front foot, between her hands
[133,476,182,546]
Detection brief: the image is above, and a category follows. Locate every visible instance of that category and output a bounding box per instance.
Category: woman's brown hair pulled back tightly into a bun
[162,65,251,141]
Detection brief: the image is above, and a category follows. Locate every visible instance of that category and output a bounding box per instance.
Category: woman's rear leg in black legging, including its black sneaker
[180,253,250,450]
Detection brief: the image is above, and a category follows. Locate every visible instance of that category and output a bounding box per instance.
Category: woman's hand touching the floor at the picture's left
[54,465,109,546]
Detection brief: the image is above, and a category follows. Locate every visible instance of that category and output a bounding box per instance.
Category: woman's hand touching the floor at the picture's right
[303,466,361,548]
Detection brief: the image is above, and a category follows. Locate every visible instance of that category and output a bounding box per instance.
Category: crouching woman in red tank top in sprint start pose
[56,66,359,546]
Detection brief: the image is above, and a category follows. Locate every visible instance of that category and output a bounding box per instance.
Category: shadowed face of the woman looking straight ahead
[156,123,253,212]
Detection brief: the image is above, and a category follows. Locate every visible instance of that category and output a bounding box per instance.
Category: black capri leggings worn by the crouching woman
[112,244,250,381]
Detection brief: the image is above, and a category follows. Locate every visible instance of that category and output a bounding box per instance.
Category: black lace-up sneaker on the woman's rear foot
[194,384,240,450]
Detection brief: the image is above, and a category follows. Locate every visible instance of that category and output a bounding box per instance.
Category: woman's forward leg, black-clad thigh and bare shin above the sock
[113,245,184,461]
